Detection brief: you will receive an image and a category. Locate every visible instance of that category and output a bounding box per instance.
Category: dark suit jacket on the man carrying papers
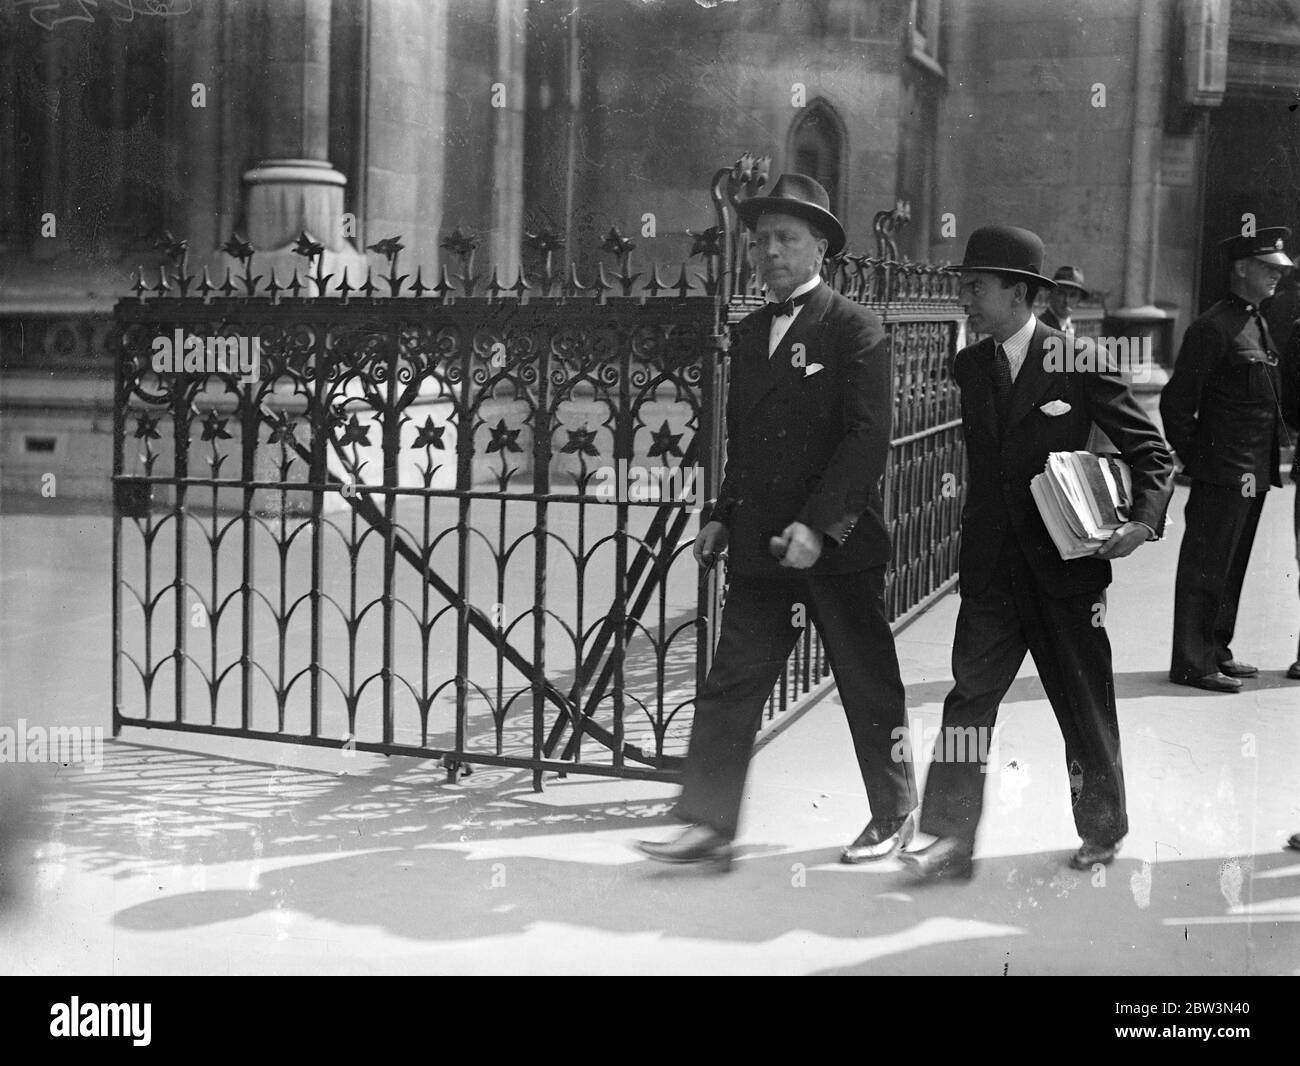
[954,315,1174,597]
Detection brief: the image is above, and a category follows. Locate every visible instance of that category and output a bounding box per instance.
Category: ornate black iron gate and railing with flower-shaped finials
[113,160,965,788]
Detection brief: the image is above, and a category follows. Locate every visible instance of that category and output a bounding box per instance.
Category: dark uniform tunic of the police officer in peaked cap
[1160,295,1288,490]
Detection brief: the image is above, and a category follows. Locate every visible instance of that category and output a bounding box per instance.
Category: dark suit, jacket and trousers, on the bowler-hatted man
[920,321,1174,848]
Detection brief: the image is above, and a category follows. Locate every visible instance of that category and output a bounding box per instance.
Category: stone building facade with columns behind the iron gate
[0,0,1300,499]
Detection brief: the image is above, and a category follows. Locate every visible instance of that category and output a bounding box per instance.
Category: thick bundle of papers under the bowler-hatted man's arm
[1030,451,1134,559]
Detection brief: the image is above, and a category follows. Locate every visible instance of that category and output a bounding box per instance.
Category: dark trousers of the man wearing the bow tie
[673,567,917,839]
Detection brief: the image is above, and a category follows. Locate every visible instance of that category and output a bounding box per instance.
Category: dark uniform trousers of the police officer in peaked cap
[1169,481,1268,681]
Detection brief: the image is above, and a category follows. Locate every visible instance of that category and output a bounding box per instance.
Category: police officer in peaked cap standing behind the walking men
[1160,226,1295,693]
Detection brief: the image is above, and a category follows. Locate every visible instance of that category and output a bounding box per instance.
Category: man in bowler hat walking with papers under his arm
[902,226,1173,880]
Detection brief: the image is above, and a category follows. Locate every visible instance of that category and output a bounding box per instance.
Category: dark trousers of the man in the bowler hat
[920,537,1128,849]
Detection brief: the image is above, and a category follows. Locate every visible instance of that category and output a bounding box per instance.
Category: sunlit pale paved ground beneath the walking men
[0,488,1300,975]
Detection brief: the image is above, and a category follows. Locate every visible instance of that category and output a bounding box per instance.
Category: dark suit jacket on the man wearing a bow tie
[710,283,893,575]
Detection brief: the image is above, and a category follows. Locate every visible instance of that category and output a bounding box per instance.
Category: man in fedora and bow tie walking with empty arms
[638,174,917,868]
